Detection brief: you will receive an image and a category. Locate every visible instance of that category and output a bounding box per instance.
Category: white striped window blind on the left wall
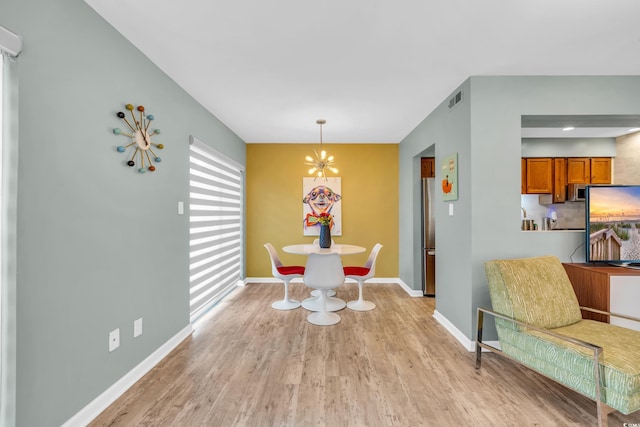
[189,138,244,322]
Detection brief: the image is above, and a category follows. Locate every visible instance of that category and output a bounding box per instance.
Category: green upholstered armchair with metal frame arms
[476,256,640,426]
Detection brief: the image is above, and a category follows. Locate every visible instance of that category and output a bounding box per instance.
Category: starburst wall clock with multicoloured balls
[113,104,164,173]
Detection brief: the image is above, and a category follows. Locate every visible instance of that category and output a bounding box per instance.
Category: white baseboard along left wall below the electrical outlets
[62,324,193,427]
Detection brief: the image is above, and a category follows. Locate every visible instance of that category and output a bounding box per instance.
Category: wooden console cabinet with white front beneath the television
[562,263,640,329]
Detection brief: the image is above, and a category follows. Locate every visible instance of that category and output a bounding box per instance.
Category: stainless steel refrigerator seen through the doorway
[422,178,436,296]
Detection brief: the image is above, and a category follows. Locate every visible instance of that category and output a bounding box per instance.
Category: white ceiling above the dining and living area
[85,0,640,143]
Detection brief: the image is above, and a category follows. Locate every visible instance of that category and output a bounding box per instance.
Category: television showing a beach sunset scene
[585,185,640,266]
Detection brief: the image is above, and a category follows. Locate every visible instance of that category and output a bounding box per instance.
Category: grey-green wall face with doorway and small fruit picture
[399,80,473,342]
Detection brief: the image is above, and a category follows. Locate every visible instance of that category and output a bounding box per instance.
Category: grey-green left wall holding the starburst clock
[0,0,245,427]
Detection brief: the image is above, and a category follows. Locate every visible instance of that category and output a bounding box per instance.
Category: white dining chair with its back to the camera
[304,253,344,326]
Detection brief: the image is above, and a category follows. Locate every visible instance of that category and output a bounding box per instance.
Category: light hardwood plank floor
[90,284,640,427]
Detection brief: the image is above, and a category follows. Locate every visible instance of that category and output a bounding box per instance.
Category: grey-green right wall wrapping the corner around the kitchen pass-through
[399,76,640,340]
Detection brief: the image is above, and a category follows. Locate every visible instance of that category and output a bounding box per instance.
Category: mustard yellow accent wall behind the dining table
[246,144,399,278]
